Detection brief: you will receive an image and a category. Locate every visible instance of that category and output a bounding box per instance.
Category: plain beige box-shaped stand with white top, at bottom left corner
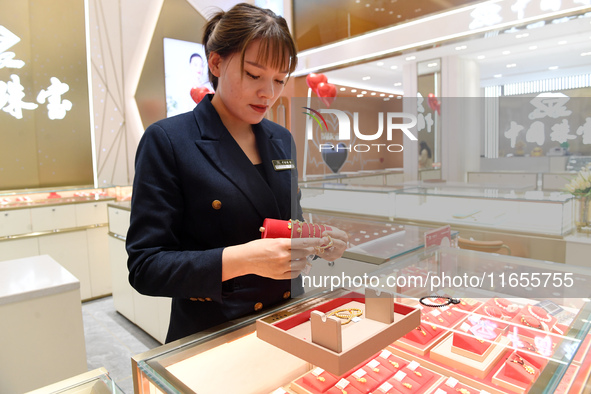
[0,255,87,393]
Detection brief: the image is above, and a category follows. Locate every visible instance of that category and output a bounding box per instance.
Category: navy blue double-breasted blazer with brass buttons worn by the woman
[126,96,302,342]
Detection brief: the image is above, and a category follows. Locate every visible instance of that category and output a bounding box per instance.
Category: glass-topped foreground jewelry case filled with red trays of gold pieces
[132,248,591,394]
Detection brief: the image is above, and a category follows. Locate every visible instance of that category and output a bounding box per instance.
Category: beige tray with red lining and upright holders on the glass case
[256,289,421,375]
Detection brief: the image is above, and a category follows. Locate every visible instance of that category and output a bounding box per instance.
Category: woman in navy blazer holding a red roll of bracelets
[127,4,347,342]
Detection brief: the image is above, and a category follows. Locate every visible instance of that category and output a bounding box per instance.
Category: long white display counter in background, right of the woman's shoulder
[301,182,573,237]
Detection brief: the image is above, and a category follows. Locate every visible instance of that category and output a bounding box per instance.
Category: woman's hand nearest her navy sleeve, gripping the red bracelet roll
[222,238,328,281]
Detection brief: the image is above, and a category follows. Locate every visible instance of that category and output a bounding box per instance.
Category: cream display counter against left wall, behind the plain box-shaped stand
[0,186,124,300]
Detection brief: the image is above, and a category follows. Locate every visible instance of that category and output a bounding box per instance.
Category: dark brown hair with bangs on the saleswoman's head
[203,3,298,89]
